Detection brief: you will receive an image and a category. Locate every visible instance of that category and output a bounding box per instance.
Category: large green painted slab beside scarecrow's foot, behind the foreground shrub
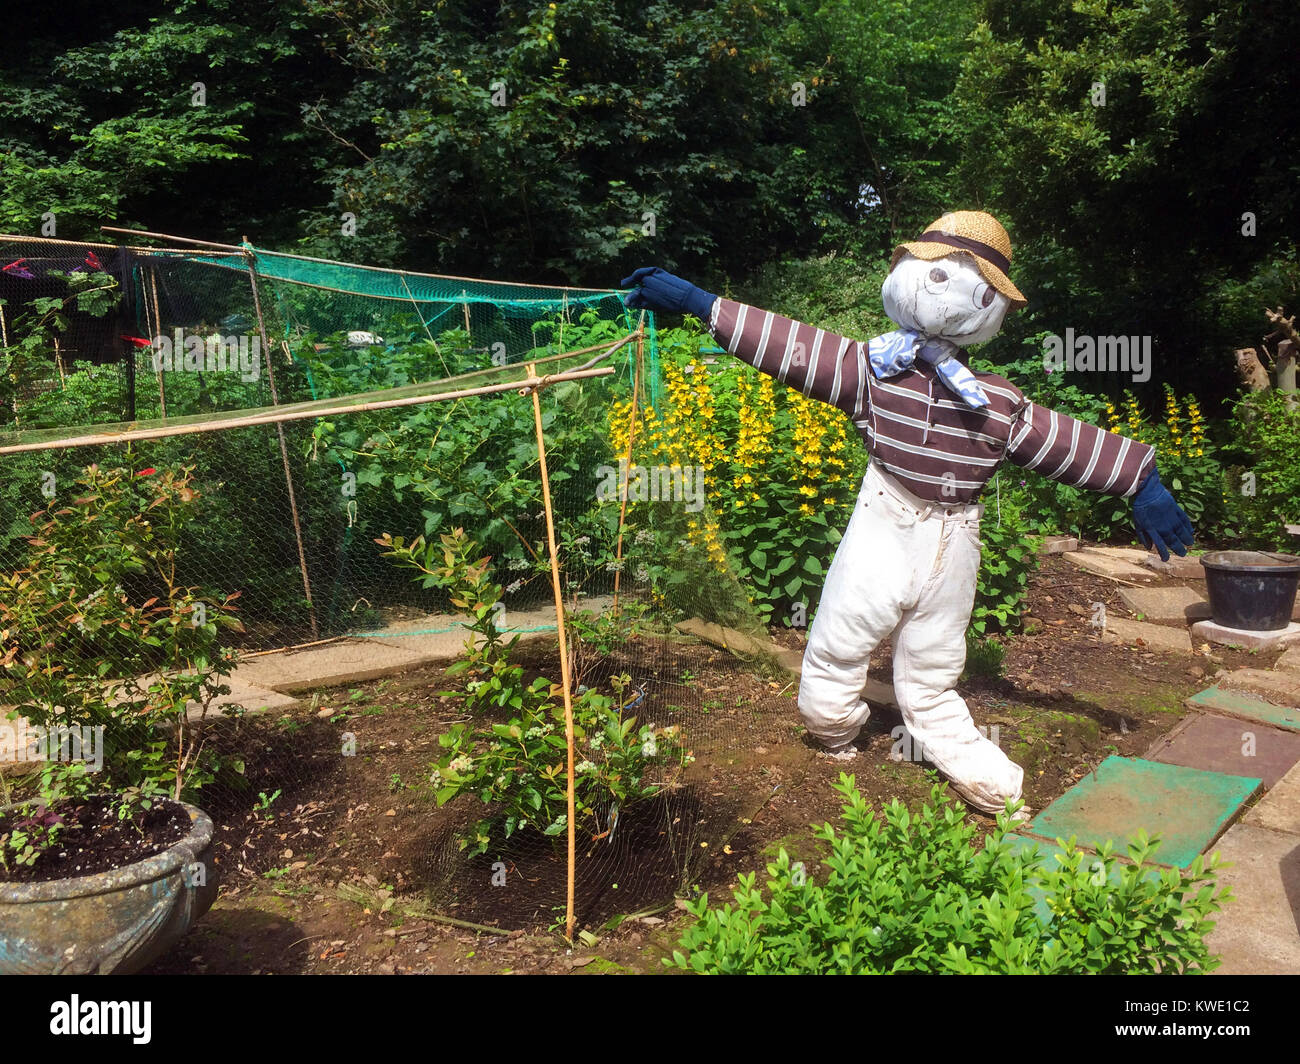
[1024,756,1260,868]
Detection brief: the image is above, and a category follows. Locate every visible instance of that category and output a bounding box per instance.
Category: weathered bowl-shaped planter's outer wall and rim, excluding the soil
[0,803,217,976]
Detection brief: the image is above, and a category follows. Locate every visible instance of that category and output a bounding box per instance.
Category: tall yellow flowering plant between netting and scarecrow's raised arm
[610,326,866,624]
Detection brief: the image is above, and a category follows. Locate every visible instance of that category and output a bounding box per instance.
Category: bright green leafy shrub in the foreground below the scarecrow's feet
[664,775,1230,974]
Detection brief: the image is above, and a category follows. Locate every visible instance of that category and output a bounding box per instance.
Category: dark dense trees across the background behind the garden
[0,0,1300,401]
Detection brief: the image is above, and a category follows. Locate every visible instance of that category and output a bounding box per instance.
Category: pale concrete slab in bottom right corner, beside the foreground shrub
[1205,823,1300,976]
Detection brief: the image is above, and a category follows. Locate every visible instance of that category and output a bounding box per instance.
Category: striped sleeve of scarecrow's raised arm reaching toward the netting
[709,298,867,421]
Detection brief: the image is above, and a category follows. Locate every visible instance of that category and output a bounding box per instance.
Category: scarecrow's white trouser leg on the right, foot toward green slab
[893,518,1024,813]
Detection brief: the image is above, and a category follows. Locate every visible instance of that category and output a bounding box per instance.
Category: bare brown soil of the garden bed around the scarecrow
[134,546,1264,973]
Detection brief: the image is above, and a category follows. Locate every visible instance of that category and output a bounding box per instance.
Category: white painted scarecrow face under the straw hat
[880,254,1011,347]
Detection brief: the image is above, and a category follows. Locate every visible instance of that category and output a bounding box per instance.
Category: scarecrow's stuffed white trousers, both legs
[800,462,1024,813]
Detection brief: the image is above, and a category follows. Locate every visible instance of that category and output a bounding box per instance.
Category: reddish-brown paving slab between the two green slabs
[1147,713,1300,790]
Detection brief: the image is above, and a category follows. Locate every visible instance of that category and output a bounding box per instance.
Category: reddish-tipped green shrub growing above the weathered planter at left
[0,455,239,799]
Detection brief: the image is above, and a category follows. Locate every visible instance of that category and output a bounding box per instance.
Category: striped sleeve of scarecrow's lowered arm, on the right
[1006,402,1156,498]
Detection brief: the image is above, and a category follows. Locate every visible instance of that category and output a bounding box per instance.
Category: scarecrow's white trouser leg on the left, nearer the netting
[800,466,941,747]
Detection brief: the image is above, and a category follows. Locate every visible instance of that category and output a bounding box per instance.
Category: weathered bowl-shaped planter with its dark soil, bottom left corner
[0,796,217,976]
